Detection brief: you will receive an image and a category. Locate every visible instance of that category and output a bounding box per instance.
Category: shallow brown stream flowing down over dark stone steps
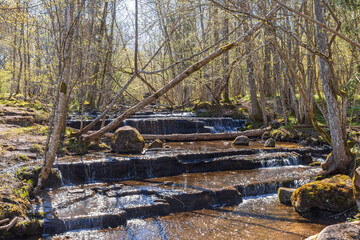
[27,116,332,240]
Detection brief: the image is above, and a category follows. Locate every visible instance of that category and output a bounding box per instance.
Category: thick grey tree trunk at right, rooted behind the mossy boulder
[315,0,351,174]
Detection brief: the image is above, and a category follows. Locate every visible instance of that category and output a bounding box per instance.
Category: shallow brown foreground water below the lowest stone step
[44,195,334,240]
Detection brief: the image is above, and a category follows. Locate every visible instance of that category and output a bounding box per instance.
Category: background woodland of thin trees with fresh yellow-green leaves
[0,0,360,123]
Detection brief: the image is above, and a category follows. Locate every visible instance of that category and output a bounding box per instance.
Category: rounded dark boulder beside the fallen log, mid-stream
[111,126,145,153]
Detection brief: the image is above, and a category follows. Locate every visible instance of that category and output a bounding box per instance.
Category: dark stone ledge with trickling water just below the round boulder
[55,148,328,184]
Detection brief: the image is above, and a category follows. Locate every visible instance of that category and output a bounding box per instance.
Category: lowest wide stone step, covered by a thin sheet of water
[33,166,319,234]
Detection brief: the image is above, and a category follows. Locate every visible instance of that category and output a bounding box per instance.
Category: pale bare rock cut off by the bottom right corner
[307,221,360,240]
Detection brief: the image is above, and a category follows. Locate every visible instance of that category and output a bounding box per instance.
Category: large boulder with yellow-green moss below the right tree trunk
[291,174,355,214]
